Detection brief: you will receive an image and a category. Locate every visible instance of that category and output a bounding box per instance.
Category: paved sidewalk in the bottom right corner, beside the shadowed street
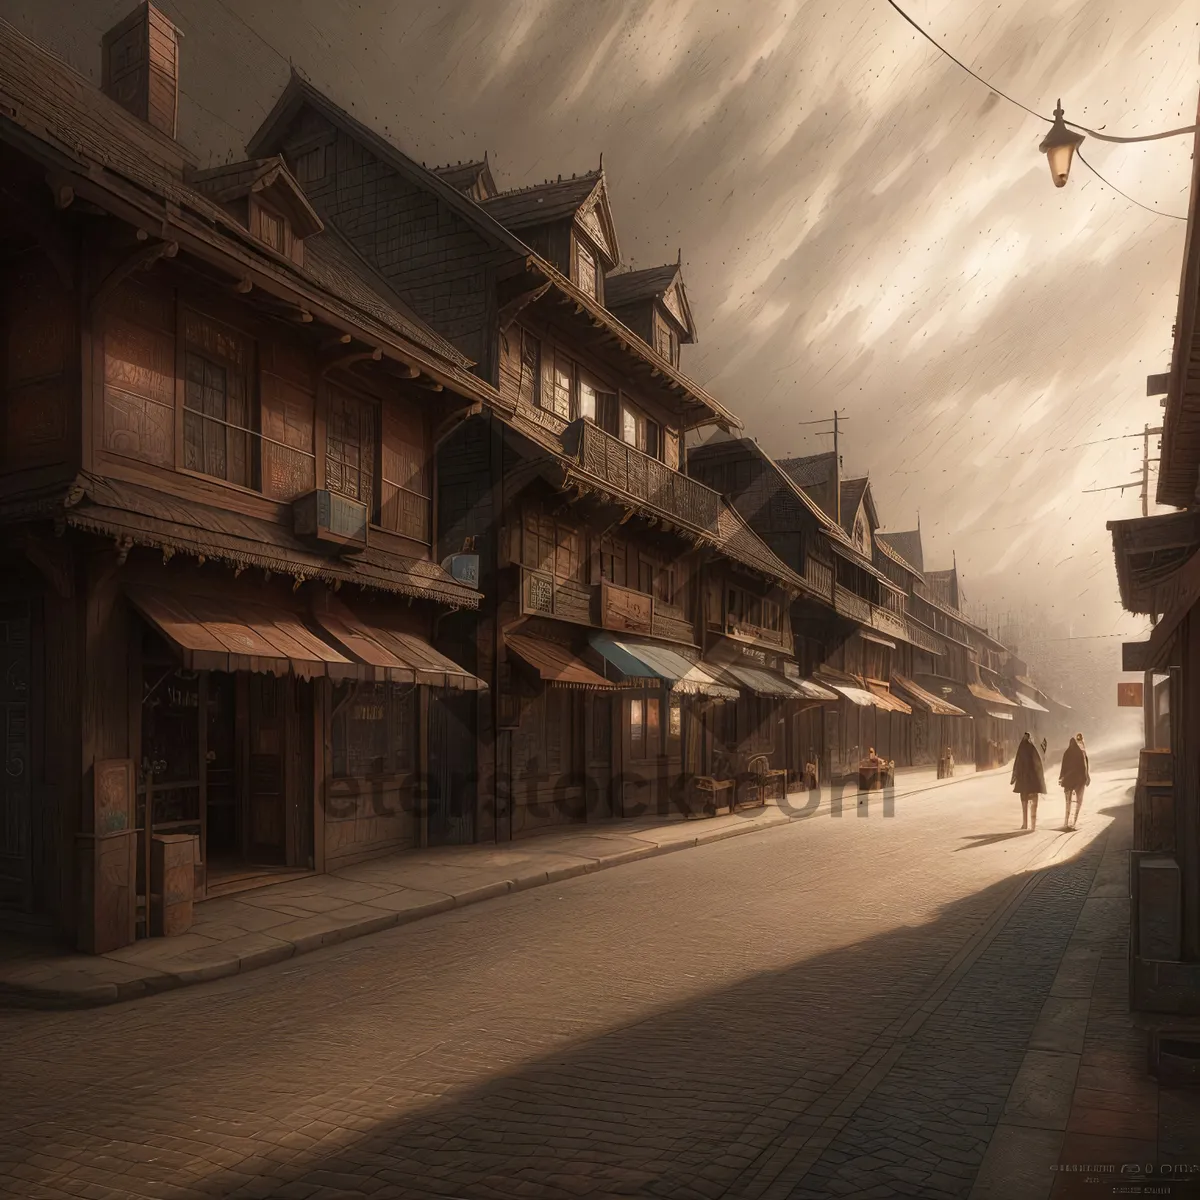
[971,805,1200,1200]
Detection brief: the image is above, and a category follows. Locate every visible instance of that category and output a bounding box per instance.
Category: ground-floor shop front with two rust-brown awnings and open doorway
[124,580,479,936]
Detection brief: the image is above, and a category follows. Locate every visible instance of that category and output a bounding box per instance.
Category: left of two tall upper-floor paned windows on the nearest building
[184,312,256,487]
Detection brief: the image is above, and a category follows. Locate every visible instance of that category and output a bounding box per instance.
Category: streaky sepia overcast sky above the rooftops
[14,0,1200,655]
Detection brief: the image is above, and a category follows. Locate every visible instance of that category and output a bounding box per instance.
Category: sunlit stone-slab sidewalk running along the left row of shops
[0,768,976,1008]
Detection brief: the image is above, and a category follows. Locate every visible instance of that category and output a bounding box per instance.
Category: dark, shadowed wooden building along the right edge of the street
[1109,96,1200,1015]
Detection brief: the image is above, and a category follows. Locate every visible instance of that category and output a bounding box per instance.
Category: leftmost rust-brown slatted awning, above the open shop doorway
[126,587,361,679]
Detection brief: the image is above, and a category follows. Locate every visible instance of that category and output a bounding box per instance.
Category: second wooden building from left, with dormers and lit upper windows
[241,78,835,839]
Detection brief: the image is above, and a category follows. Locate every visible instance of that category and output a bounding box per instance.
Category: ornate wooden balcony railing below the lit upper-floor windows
[563,418,720,532]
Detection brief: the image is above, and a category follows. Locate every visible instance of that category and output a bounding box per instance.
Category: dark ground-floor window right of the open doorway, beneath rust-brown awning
[332,683,416,779]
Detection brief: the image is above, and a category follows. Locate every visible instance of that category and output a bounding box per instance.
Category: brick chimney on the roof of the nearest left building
[101,2,179,138]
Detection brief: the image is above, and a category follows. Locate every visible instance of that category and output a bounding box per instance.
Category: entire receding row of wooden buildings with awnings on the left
[0,5,1060,952]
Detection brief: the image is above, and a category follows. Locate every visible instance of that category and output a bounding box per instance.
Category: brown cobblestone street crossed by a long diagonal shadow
[0,769,1133,1200]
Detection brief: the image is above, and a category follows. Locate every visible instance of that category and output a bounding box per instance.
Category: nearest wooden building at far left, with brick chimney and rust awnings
[0,5,502,952]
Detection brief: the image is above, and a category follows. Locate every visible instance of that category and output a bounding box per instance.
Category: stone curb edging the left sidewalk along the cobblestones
[0,772,1017,1010]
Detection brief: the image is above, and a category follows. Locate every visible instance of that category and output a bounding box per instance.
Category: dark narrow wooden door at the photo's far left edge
[0,600,34,912]
